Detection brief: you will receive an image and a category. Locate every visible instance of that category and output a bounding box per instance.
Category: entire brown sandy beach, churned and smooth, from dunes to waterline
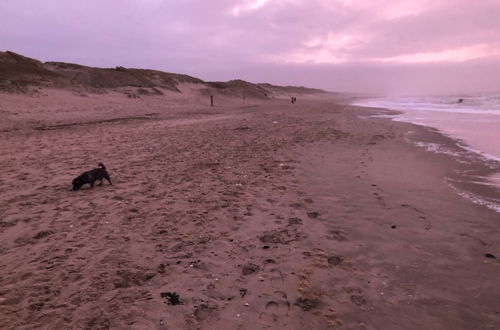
[0,86,500,329]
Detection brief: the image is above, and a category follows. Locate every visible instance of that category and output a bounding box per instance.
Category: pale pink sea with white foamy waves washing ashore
[353,93,500,212]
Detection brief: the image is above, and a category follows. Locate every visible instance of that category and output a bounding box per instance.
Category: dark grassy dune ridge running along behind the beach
[0,51,327,98]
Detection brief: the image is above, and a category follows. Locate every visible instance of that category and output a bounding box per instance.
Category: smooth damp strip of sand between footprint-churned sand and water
[290,105,500,329]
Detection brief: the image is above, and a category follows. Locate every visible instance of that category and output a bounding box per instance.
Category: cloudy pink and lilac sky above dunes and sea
[0,0,500,94]
